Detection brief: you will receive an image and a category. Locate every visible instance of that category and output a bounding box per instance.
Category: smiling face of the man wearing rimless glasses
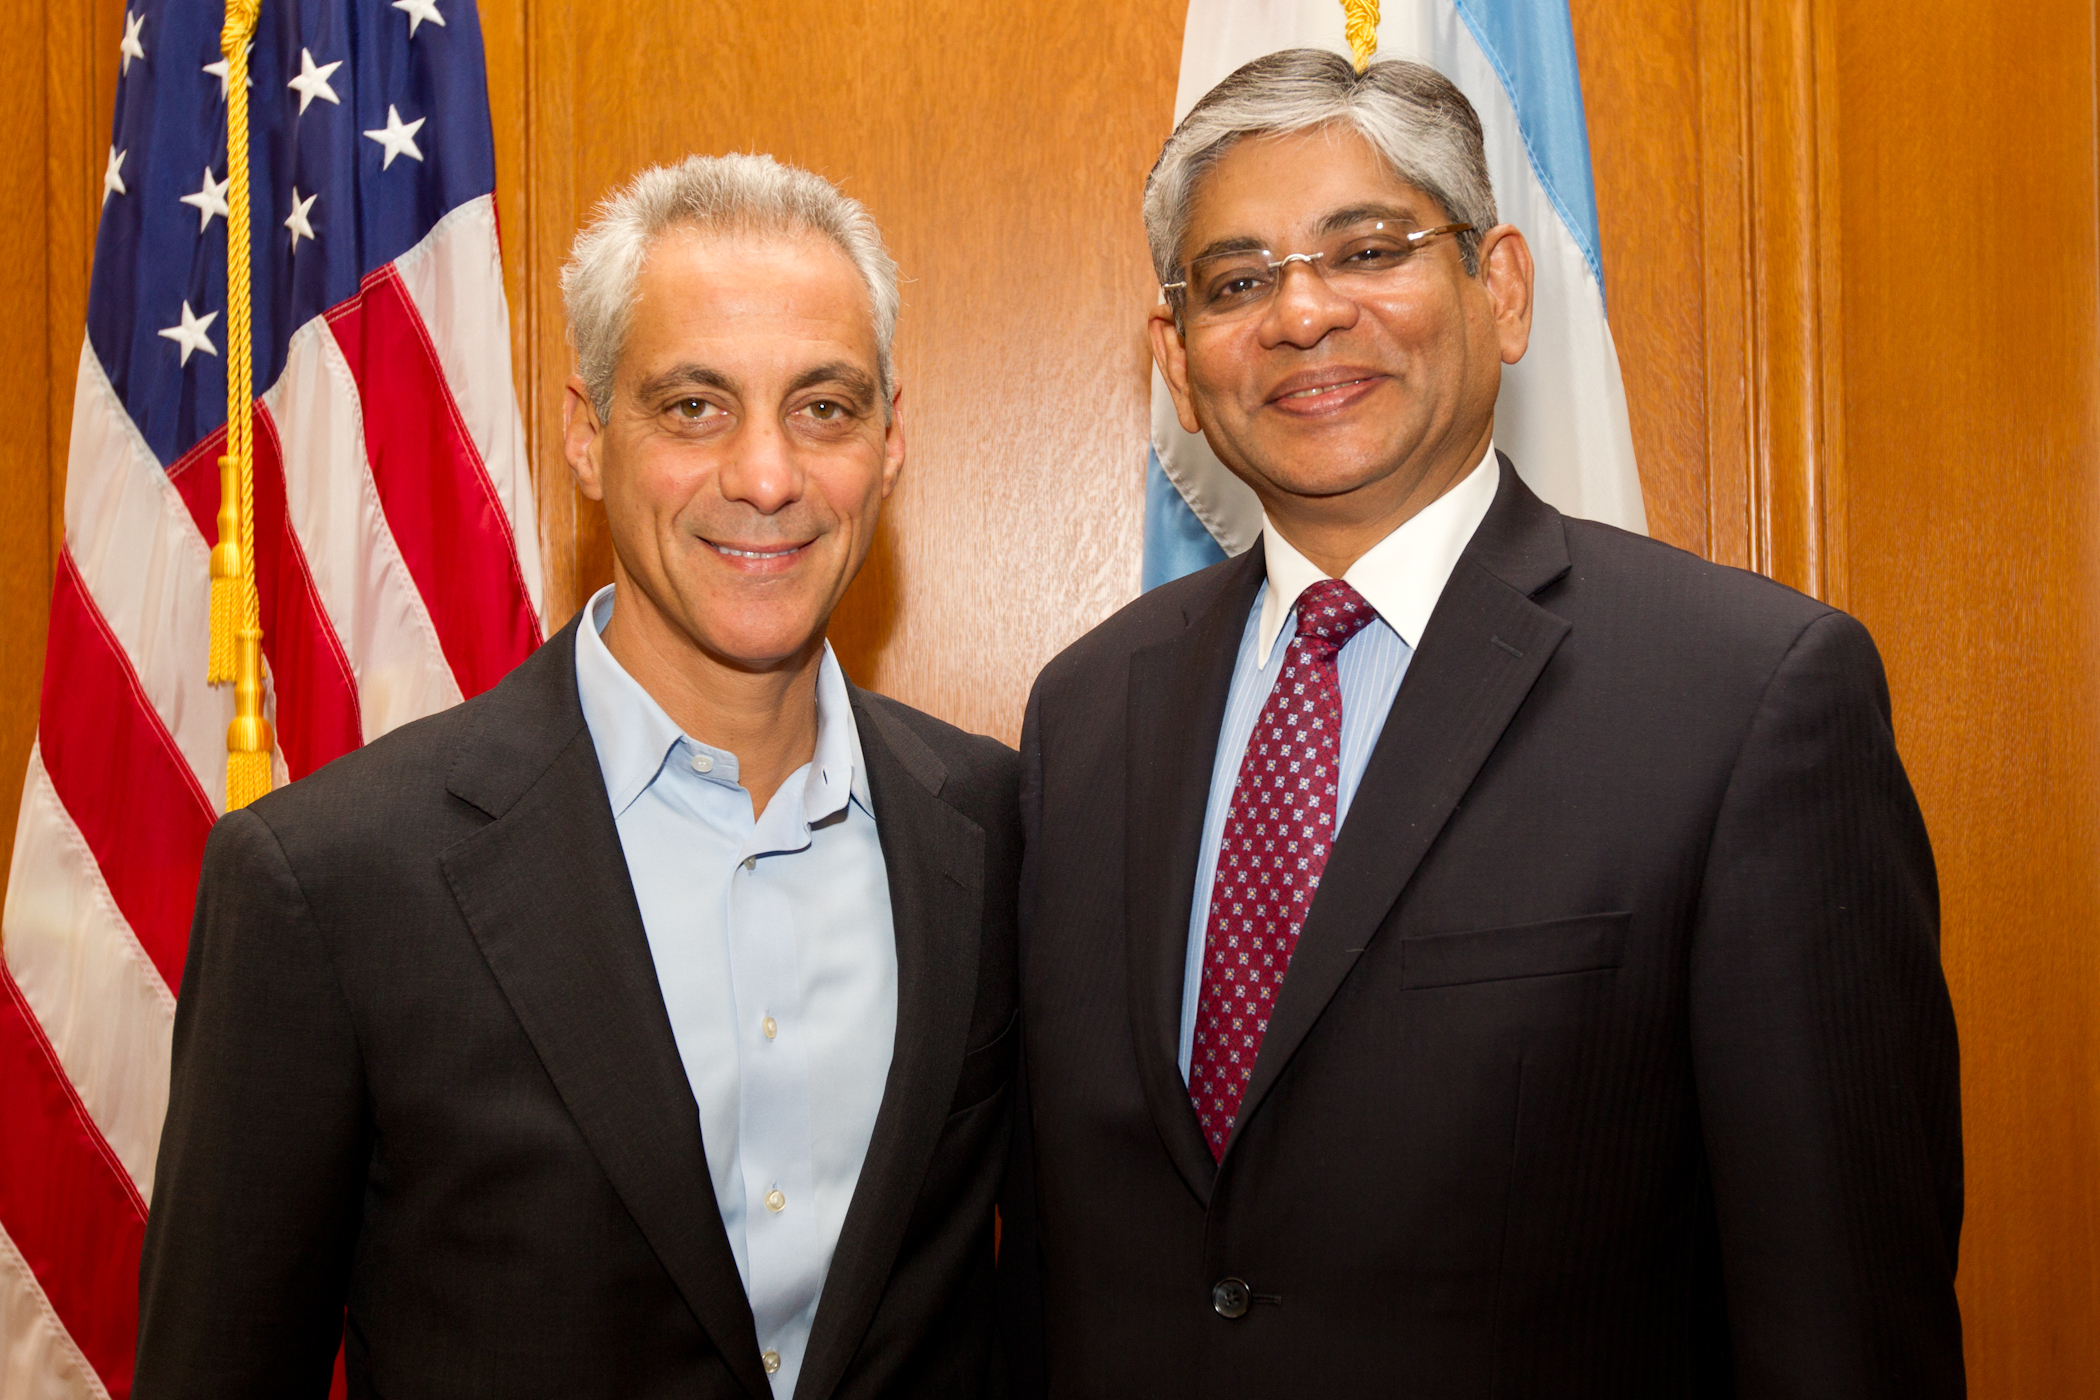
[1151,128,1531,558]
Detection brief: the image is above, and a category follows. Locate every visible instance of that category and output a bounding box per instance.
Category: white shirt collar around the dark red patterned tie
[1254,441,1502,670]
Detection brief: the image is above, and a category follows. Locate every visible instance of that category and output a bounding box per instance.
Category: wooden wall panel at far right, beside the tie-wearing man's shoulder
[1833,0,2100,1400]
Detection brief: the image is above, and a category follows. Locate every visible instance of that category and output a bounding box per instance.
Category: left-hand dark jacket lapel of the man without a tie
[439,623,771,1400]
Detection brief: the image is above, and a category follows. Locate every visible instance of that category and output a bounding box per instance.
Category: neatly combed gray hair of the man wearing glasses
[1145,48,1495,283]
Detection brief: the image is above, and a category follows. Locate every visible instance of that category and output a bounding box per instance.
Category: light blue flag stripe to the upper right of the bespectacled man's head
[1453,0,1604,292]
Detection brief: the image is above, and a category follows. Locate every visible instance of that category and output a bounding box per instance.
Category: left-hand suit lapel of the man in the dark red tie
[1124,544,1266,1203]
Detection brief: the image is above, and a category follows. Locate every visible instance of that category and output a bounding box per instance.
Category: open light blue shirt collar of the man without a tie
[575,584,874,825]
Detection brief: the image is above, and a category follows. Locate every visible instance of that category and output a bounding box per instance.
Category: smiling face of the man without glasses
[565,229,905,672]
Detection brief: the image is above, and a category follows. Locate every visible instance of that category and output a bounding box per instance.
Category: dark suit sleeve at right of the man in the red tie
[1691,613,1964,1400]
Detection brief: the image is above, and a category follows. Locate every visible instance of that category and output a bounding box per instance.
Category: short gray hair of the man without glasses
[561,155,897,418]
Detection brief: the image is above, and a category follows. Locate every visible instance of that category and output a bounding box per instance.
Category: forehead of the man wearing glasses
[1182,126,1443,256]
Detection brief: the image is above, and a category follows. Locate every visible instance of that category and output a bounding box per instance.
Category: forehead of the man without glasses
[622,229,876,372]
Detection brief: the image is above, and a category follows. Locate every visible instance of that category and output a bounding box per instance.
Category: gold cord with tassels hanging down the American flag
[208,0,275,812]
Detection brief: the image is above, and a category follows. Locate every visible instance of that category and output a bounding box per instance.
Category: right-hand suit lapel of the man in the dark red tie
[1226,458,1569,1152]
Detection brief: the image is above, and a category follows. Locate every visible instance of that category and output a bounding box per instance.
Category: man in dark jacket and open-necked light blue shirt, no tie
[137,155,1021,1400]
